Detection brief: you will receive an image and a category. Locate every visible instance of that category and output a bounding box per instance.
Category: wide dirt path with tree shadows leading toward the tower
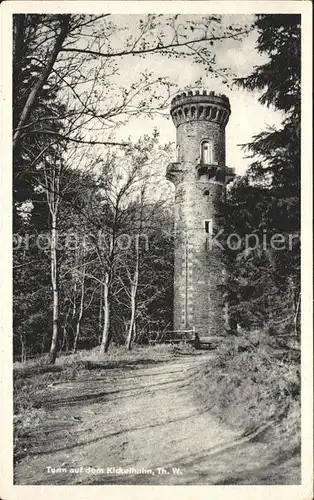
[15,354,299,485]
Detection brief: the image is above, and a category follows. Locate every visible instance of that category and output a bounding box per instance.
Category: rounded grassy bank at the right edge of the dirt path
[197,332,301,448]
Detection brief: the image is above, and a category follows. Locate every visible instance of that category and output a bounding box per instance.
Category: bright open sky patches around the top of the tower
[106,15,282,174]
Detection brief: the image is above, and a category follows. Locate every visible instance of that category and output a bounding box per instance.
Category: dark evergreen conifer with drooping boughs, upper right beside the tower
[237,14,301,211]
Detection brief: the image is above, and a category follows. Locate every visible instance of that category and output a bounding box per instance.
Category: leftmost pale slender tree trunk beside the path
[49,213,59,363]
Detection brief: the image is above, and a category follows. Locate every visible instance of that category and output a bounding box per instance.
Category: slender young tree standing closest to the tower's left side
[119,182,173,350]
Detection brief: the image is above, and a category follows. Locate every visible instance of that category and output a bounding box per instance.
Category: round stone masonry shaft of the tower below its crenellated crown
[174,115,225,337]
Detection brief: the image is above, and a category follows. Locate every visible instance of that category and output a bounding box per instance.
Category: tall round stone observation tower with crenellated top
[166,90,235,338]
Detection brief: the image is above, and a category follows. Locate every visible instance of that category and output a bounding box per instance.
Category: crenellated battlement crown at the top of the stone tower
[170,89,231,127]
